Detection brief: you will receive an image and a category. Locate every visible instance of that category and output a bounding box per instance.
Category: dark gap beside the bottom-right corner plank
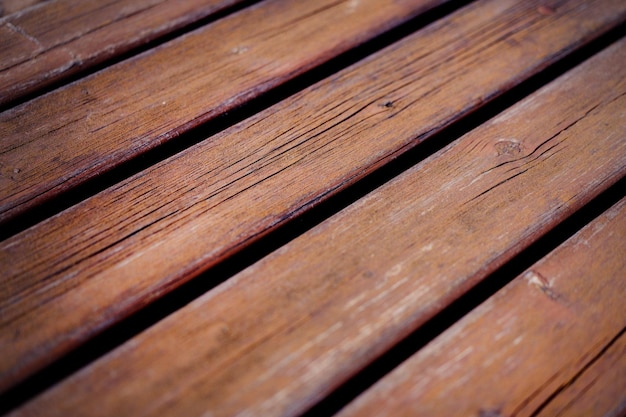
[302,177,626,417]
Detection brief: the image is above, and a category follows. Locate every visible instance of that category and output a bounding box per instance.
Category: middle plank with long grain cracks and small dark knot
[0,0,626,394]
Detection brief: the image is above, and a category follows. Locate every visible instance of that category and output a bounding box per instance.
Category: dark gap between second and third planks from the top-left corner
[0,0,471,241]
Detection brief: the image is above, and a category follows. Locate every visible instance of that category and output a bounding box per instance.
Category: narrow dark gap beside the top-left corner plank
[0,0,261,112]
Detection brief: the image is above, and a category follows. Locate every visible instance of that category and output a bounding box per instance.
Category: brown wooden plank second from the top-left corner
[0,0,445,222]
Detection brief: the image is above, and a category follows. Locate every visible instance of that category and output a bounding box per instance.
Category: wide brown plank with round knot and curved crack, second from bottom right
[9,35,626,416]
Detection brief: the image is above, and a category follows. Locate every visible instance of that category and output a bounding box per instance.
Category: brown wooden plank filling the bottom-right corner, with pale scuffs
[340,197,626,417]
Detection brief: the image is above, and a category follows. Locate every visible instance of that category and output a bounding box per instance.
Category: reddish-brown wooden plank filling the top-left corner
[0,0,242,105]
